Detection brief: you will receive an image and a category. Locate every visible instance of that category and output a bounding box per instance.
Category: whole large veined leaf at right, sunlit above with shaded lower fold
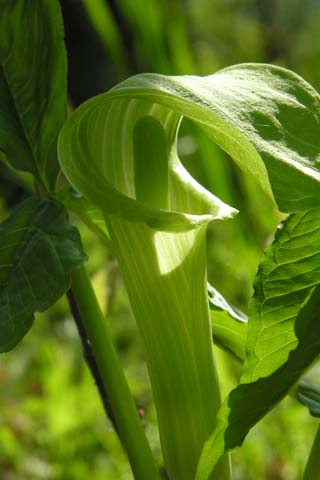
[197,209,320,480]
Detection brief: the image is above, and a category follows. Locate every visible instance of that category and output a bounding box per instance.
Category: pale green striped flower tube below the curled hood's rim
[108,217,230,480]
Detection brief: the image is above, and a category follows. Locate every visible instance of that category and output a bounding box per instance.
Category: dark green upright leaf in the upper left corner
[0,0,67,189]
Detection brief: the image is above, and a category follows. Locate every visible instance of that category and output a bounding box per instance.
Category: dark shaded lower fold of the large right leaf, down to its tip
[196,287,320,480]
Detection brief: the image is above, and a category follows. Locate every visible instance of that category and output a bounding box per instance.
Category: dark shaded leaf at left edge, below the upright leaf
[0,197,86,352]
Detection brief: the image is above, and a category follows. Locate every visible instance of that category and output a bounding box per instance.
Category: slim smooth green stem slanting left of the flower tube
[72,267,159,480]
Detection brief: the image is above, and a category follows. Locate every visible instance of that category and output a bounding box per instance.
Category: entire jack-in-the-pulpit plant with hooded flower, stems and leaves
[0,0,320,480]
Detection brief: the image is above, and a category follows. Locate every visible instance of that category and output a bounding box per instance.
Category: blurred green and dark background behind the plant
[0,0,320,480]
